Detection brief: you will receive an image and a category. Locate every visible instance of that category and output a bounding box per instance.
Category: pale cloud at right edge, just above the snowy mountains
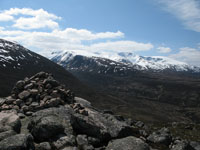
[169,47,200,66]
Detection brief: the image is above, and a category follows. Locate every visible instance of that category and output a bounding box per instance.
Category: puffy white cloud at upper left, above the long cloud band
[0,8,61,29]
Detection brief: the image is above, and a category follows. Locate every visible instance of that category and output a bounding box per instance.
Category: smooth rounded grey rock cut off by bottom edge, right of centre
[106,136,149,150]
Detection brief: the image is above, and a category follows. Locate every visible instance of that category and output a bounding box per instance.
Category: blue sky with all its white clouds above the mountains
[0,0,200,66]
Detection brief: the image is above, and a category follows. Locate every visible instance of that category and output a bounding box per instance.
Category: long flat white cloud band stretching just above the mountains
[0,28,153,52]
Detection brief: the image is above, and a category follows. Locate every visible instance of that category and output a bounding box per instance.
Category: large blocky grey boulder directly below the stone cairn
[28,106,73,142]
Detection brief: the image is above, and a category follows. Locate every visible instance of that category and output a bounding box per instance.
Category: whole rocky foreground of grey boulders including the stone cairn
[0,72,200,150]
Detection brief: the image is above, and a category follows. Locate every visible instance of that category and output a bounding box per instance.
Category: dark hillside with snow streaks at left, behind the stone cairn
[0,39,92,97]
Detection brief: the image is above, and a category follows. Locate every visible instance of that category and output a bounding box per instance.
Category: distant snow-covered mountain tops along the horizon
[49,51,200,73]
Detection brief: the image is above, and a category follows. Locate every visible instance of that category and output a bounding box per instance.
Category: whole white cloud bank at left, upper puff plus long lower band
[0,8,154,56]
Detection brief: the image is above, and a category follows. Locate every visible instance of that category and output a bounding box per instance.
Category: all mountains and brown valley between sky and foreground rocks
[0,39,200,122]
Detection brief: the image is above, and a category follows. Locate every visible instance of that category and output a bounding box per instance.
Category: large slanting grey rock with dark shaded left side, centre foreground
[73,108,134,141]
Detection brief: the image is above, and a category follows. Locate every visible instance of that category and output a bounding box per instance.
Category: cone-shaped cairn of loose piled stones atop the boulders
[0,72,74,117]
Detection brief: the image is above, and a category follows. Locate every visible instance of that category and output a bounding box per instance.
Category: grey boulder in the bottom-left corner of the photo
[0,134,35,150]
